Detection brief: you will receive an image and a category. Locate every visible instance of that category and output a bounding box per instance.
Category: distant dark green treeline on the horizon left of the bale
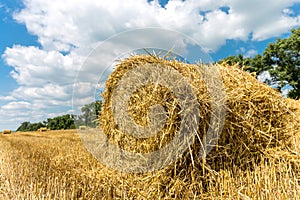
[17,101,102,131]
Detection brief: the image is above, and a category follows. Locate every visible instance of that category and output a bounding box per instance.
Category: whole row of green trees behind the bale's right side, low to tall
[220,28,300,99]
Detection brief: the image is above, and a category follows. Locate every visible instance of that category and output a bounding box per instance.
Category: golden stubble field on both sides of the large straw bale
[0,126,300,199]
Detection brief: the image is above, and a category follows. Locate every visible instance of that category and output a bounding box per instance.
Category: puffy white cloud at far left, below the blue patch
[2,45,84,86]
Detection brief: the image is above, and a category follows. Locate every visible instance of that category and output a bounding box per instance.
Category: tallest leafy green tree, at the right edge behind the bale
[263,28,300,99]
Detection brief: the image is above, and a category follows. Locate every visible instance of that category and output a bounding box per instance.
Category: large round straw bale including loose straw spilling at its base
[99,55,297,198]
